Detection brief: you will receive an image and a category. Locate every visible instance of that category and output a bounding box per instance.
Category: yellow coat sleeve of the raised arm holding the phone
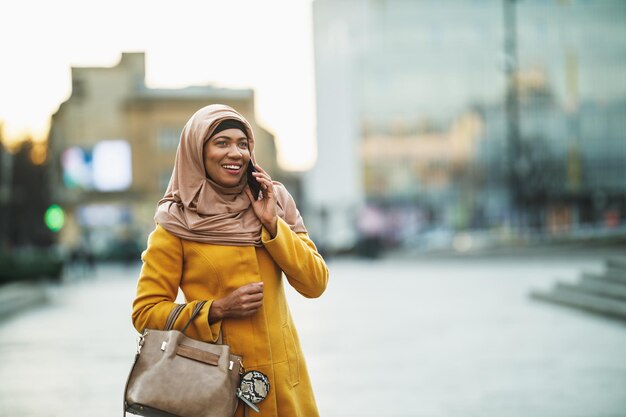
[261,217,328,298]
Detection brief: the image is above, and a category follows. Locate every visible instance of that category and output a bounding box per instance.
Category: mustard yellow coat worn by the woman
[132,218,328,417]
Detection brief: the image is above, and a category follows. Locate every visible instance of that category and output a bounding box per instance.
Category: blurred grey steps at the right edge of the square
[530,257,626,321]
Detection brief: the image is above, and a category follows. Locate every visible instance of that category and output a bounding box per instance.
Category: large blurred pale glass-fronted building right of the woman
[305,0,626,248]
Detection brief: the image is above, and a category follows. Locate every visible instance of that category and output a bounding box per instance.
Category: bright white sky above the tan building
[0,0,316,170]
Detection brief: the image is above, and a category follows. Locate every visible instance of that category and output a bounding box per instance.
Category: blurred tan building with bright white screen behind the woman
[49,53,284,257]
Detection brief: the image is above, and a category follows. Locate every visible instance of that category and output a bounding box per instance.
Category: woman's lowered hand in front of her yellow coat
[209,282,263,323]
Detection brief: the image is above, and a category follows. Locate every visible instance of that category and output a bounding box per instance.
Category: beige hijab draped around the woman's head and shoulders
[154,104,306,246]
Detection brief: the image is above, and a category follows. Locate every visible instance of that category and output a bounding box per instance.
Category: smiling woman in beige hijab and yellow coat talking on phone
[132,105,328,417]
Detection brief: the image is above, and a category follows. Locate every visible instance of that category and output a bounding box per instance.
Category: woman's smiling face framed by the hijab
[204,129,250,187]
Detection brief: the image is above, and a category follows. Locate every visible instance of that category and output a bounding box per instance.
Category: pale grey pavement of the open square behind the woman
[0,254,626,417]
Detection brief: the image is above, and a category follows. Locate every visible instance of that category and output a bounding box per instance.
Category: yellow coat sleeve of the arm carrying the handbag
[132,226,221,341]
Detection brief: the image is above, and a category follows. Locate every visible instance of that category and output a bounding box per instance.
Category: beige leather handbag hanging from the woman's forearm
[124,301,243,417]
